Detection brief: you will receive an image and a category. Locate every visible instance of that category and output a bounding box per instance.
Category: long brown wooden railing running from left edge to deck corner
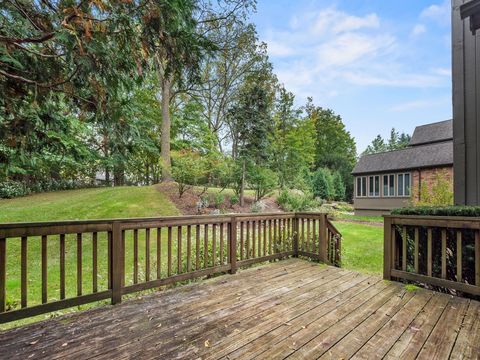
[0,213,341,323]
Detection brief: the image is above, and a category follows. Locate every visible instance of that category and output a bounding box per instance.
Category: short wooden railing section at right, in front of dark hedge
[384,215,480,295]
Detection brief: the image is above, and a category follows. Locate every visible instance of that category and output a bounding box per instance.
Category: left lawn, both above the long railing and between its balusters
[0,187,179,326]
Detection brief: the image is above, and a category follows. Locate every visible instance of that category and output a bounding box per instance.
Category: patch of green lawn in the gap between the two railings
[334,221,383,275]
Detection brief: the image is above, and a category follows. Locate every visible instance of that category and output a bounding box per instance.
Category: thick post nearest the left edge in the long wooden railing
[110,222,124,305]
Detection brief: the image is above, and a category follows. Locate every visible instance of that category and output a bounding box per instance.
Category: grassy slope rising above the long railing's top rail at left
[0,186,178,223]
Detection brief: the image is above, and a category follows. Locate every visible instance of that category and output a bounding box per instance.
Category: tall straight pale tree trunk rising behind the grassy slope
[160,77,172,181]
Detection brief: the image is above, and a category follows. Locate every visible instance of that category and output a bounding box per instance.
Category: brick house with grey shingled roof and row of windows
[352,120,453,215]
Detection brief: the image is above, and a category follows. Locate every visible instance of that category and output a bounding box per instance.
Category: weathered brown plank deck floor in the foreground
[0,259,480,359]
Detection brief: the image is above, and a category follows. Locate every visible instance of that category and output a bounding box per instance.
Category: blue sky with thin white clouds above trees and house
[252,0,452,153]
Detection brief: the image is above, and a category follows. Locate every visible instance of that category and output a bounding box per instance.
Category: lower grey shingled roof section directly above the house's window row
[352,141,453,175]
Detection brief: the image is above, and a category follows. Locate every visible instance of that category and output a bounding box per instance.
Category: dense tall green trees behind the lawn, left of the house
[0,0,356,202]
